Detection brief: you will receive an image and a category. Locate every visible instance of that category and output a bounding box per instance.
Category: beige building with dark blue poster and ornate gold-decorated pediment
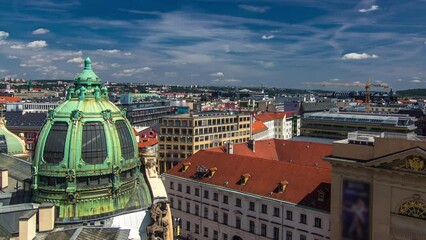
[325,132,426,240]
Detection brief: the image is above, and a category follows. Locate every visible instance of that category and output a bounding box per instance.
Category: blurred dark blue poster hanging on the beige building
[342,180,370,240]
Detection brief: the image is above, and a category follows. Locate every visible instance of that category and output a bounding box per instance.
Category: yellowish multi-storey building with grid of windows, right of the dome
[158,112,252,173]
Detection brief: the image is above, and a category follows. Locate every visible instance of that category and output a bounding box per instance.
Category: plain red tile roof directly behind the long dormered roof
[206,139,332,169]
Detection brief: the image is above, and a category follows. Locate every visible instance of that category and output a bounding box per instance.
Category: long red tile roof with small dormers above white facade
[166,150,331,211]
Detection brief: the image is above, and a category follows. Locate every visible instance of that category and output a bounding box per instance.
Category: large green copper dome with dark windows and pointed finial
[33,58,151,222]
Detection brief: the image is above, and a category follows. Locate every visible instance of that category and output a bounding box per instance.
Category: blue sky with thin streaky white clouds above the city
[0,0,426,89]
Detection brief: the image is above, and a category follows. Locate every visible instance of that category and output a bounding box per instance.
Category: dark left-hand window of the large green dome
[43,122,68,164]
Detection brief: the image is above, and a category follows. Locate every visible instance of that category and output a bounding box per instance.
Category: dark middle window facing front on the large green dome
[81,122,107,164]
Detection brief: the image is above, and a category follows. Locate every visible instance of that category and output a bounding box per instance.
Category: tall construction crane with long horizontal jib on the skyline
[302,78,390,112]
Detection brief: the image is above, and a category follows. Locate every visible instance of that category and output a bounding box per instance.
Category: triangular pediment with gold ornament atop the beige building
[365,147,426,174]
